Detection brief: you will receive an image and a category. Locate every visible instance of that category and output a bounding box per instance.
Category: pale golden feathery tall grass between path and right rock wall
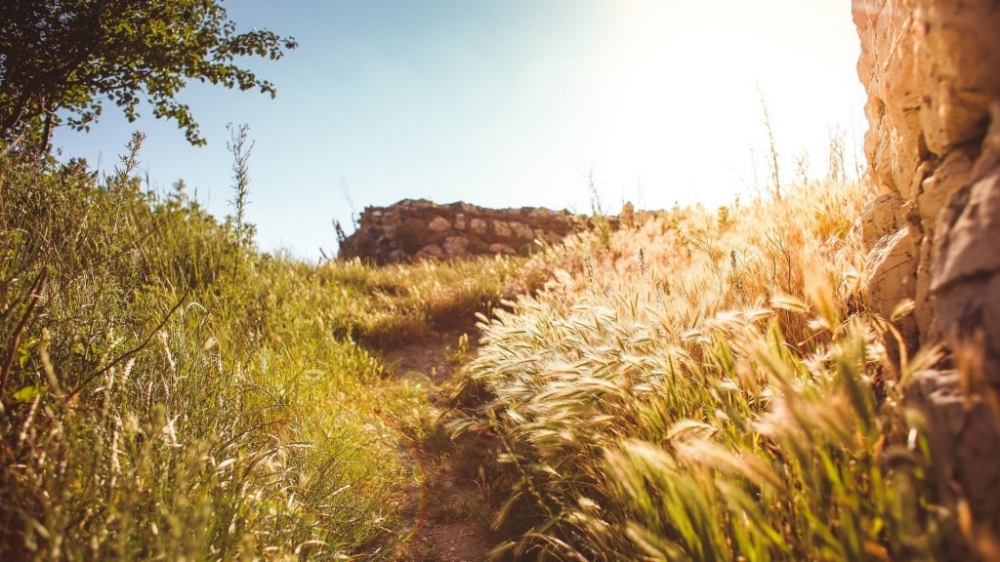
[450,178,952,561]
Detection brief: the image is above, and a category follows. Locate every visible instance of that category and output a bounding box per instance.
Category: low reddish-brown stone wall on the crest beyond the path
[340,199,583,264]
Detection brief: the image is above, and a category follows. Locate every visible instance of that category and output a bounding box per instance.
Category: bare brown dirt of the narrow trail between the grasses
[383,333,497,562]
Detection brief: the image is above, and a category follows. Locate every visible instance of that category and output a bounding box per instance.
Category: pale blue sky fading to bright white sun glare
[53,0,866,260]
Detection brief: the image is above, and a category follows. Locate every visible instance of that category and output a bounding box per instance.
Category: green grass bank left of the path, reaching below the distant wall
[0,136,540,560]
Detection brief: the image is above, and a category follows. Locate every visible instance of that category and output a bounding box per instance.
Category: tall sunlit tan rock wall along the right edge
[853,0,1000,544]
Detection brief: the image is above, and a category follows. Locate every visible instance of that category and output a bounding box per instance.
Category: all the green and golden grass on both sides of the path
[0,141,941,560]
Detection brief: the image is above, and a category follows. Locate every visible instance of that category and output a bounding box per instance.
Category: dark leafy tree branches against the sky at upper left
[0,0,297,151]
